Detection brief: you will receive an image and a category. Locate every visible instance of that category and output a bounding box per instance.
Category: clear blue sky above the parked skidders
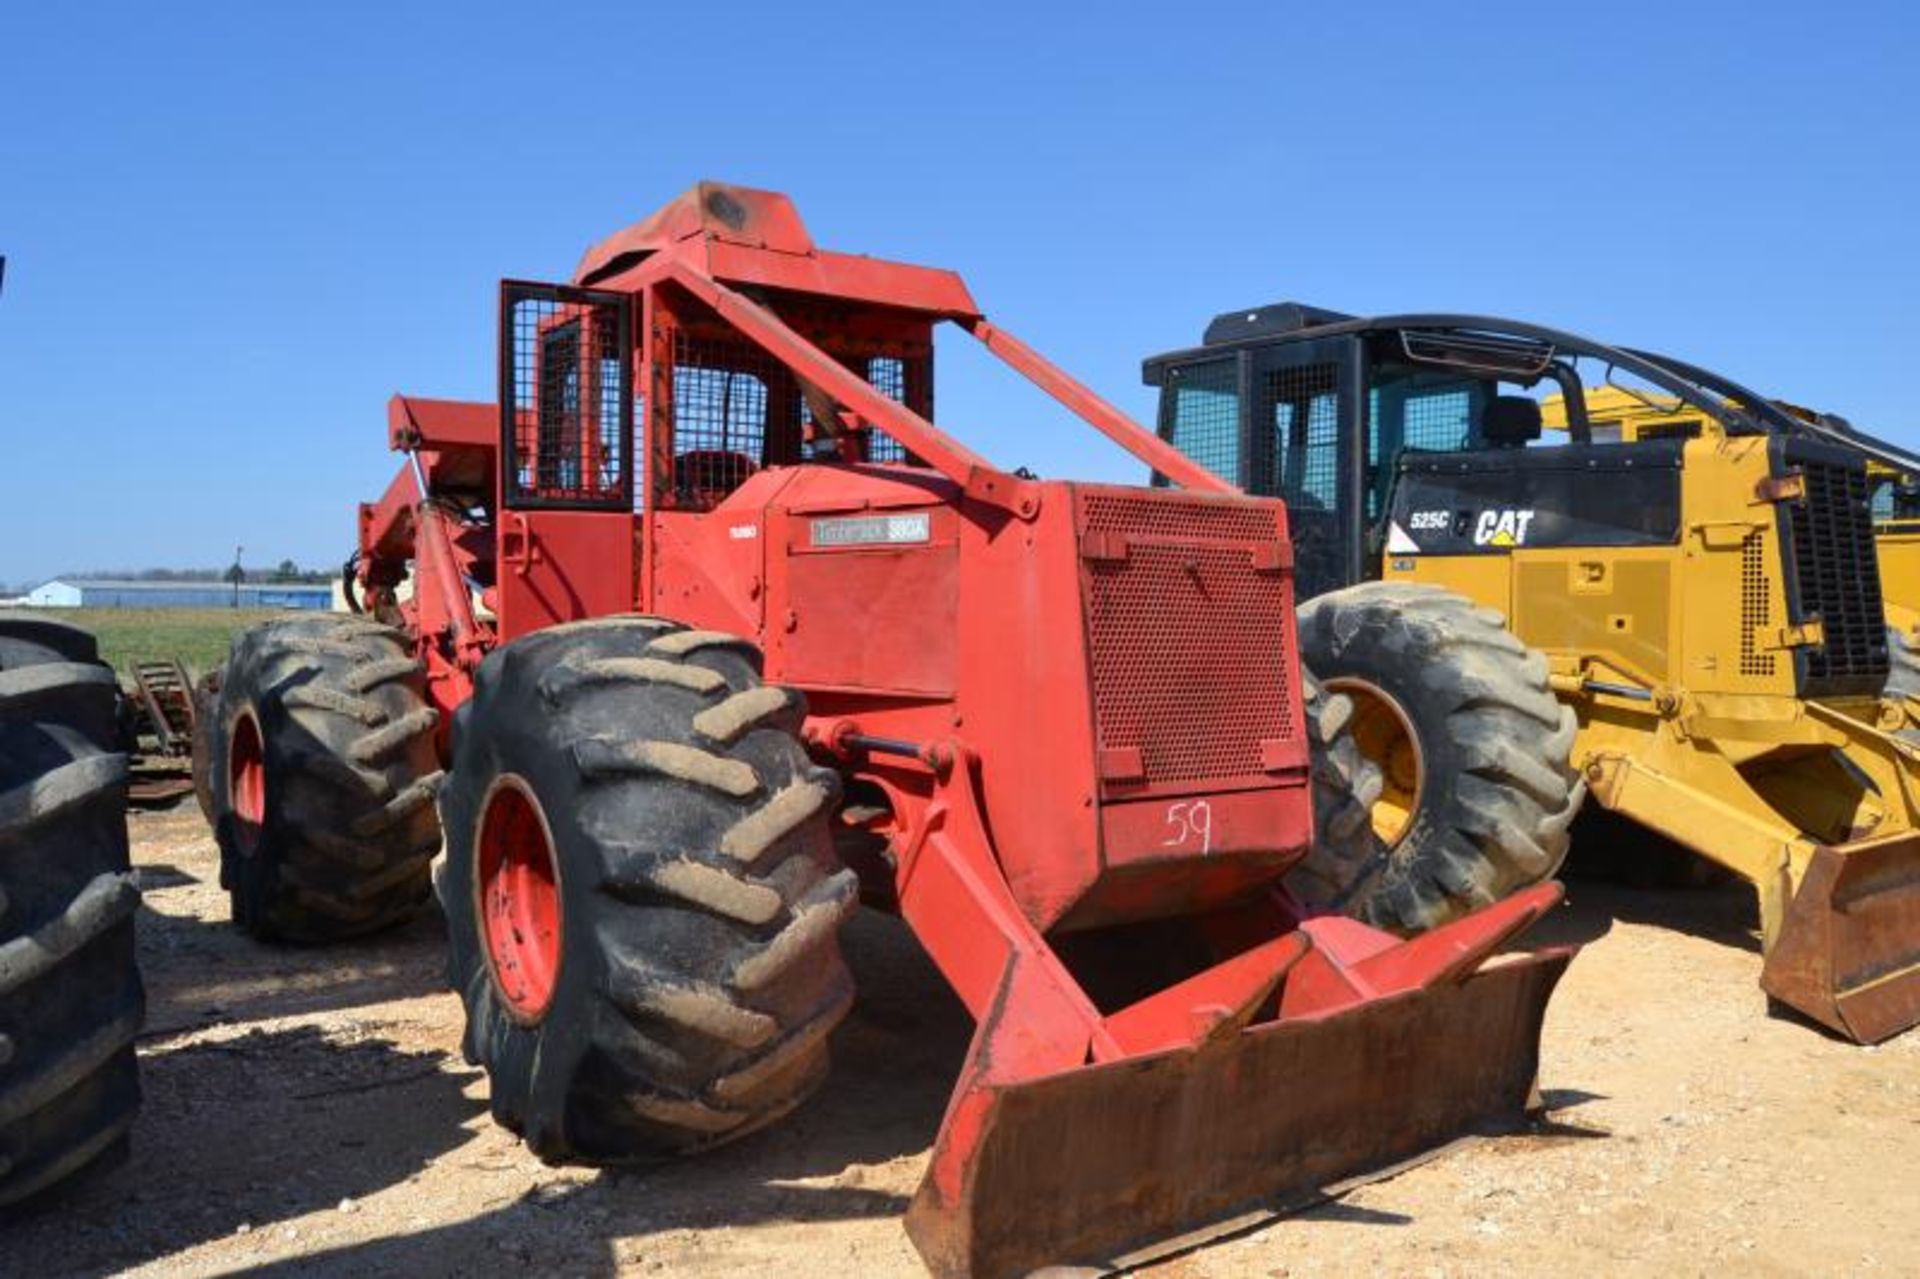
[0,2,1920,584]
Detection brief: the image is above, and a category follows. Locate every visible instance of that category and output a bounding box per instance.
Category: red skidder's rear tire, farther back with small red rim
[202,616,440,943]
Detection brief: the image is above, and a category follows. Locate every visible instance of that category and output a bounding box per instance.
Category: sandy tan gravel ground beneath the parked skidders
[0,801,1920,1279]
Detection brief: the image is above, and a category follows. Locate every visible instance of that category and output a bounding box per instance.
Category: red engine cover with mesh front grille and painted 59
[651,467,1311,929]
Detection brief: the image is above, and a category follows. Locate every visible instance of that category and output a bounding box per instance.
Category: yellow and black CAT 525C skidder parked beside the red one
[1144,303,1920,1043]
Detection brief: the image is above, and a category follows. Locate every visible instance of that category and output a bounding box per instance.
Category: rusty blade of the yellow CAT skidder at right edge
[1761,833,1920,1043]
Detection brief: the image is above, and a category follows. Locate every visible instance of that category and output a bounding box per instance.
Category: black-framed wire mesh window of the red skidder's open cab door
[499,280,634,511]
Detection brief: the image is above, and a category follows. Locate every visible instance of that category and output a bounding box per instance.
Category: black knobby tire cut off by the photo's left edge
[0,618,146,1208]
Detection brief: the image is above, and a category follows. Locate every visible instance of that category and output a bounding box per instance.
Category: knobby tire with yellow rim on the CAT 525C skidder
[1300,582,1586,933]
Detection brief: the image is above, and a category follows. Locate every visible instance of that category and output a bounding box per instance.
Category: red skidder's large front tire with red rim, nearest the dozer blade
[440,616,858,1164]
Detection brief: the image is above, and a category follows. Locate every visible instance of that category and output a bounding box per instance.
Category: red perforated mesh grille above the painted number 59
[1081,492,1296,784]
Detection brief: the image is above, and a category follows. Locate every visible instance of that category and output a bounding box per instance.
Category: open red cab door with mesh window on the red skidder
[497,280,636,640]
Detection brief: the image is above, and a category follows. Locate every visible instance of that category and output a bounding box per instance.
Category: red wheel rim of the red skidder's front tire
[478,776,561,1022]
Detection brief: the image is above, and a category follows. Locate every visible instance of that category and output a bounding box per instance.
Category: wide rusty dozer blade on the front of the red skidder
[906,883,1572,1277]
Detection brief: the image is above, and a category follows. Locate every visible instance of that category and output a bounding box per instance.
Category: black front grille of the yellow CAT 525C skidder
[1788,459,1887,693]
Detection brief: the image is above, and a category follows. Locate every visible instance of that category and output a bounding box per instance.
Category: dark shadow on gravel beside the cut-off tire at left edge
[0,1027,480,1273]
